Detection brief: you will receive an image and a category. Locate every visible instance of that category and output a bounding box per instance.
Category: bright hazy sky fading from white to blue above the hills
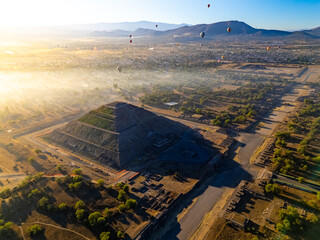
[0,0,320,30]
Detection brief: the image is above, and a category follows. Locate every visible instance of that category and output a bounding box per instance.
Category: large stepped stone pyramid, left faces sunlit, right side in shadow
[43,102,187,169]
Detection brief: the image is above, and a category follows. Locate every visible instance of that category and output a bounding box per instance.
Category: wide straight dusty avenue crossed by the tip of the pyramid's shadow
[150,81,308,240]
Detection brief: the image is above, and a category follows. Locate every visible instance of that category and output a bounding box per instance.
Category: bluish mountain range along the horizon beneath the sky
[90,21,320,41]
